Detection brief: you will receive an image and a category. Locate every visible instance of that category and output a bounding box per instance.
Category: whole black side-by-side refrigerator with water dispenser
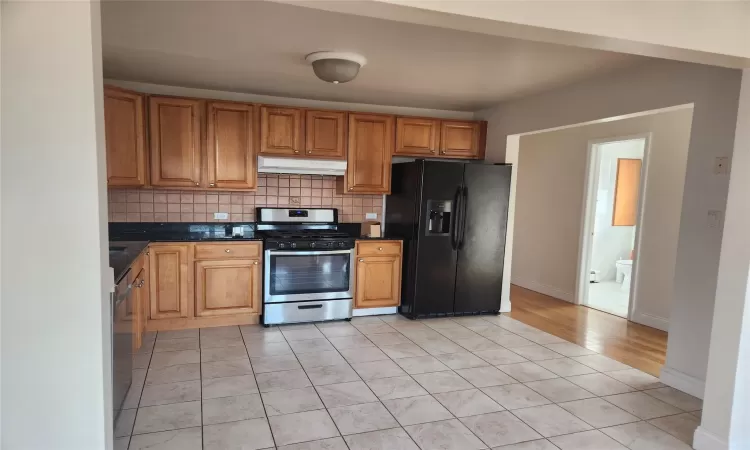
[385,160,511,318]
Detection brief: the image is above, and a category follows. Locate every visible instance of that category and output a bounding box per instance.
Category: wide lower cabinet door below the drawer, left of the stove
[195,259,262,317]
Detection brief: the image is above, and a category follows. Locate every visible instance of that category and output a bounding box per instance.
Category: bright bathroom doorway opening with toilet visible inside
[577,135,649,318]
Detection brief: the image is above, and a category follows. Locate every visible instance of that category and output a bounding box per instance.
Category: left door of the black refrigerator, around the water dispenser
[414,161,463,316]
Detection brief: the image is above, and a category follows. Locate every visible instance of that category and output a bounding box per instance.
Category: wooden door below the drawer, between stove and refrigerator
[354,255,401,308]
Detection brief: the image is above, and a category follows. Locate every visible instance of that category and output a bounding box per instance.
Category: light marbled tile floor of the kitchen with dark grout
[115,315,702,450]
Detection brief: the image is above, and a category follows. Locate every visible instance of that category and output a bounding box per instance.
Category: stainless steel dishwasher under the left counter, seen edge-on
[111,270,134,421]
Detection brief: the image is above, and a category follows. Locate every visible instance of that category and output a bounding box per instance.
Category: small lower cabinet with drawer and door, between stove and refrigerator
[354,241,403,309]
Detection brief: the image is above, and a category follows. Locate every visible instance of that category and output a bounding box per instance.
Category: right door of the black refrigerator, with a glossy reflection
[455,164,511,314]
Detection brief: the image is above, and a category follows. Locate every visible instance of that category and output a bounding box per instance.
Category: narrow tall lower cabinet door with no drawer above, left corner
[149,244,192,319]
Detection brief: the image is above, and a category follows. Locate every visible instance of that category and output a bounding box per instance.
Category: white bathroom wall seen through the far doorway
[591,138,648,281]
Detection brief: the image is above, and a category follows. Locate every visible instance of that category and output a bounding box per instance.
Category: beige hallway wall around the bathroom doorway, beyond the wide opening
[511,108,692,329]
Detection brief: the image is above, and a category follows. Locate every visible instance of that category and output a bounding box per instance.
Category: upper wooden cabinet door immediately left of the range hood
[206,102,258,189]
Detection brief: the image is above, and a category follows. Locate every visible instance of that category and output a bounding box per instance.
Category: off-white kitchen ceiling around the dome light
[102,0,648,111]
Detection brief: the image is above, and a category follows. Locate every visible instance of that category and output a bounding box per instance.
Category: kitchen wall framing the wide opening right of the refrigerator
[478,61,742,394]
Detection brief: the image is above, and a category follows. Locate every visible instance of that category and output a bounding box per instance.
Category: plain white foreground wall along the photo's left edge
[0,2,112,450]
